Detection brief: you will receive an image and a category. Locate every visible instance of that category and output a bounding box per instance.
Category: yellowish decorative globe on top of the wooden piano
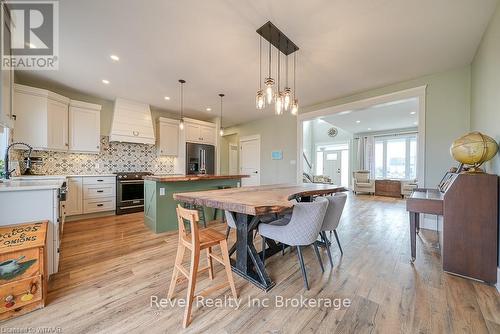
[450,132,498,171]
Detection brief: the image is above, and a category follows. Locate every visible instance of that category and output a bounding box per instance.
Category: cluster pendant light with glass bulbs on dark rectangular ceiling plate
[255,22,299,115]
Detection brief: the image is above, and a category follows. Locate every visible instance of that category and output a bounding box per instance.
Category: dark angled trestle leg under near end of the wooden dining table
[231,213,274,291]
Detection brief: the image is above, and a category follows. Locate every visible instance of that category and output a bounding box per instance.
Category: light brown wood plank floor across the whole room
[0,195,500,333]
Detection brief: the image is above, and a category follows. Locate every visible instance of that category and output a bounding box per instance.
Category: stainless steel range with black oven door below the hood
[116,172,153,215]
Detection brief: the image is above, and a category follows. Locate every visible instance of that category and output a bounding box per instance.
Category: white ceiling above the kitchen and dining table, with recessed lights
[19,0,497,126]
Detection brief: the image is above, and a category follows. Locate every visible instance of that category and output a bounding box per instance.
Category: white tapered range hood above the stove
[109,98,155,145]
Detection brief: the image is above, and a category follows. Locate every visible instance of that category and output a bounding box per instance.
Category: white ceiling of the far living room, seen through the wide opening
[320,98,418,133]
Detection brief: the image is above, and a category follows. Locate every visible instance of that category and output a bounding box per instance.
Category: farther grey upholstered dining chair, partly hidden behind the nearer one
[320,193,347,267]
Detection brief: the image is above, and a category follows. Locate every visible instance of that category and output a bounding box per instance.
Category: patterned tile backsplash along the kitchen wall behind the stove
[12,136,174,175]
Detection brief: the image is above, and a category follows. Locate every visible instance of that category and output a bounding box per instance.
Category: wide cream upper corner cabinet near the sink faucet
[13,84,69,151]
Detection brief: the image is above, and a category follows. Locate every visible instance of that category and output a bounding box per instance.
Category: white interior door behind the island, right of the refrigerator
[239,135,260,187]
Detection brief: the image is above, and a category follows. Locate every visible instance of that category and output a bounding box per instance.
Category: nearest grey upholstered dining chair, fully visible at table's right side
[259,198,328,290]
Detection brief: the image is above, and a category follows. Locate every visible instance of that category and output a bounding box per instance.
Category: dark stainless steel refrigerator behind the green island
[186,143,215,174]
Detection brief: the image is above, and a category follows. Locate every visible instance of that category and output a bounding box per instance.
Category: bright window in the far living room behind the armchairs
[375,134,417,179]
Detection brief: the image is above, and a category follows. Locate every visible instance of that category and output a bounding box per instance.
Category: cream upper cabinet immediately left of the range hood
[69,100,101,153]
